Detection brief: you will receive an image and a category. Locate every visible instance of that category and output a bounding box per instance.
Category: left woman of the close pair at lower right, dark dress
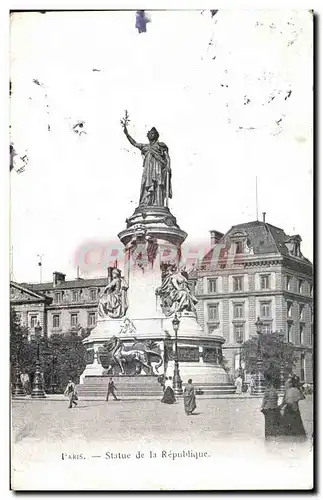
[261,379,281,439]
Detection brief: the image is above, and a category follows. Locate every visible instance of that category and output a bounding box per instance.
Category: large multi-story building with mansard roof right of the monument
[190,218,313,382]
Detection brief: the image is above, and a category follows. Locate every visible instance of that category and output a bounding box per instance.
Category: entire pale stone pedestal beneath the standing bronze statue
[82,207,232,385]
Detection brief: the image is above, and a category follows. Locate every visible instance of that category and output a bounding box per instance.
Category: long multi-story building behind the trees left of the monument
[10,272,108,336]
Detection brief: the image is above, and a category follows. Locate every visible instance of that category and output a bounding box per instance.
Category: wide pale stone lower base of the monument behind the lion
[80,312,235,393]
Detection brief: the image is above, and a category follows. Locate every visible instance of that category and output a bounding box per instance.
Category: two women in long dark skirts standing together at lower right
[261,374,306,441]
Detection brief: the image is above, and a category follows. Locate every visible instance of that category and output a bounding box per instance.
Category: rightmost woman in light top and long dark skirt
[281,376,307,441]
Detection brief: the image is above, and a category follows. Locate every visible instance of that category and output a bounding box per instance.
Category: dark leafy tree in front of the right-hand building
[241,332,297,378]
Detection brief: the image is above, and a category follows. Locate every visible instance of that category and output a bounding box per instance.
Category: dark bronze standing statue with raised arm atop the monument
[121,115,172,207]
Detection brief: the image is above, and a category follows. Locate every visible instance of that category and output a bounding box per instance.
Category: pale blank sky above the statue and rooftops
[10,10,313,282]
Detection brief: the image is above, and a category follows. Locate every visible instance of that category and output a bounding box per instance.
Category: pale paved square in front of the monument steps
[12,398,313,441]
